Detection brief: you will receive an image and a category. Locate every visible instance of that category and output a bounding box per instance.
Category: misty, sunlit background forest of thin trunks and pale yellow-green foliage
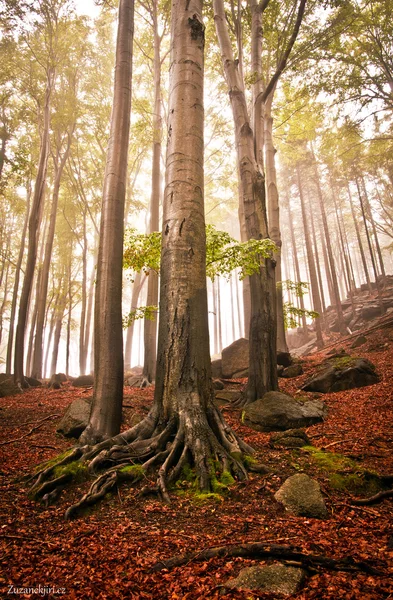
[0,0,393,379]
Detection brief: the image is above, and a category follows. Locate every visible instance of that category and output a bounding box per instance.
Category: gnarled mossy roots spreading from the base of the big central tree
[26,399,254,518]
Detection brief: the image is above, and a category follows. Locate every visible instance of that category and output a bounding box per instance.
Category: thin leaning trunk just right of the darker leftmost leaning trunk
[32,134,72,379]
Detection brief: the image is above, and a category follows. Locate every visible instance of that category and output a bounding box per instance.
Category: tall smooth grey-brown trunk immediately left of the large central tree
[82,0,134,443]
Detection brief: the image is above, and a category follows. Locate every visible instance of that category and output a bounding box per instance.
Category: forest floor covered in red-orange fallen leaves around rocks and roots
[0,327,393,600]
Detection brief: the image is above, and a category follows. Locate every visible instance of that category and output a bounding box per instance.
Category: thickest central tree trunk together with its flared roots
[27,0,252,517]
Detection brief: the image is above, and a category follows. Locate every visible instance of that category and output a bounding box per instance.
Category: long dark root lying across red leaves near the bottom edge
[150,542,383,575]
